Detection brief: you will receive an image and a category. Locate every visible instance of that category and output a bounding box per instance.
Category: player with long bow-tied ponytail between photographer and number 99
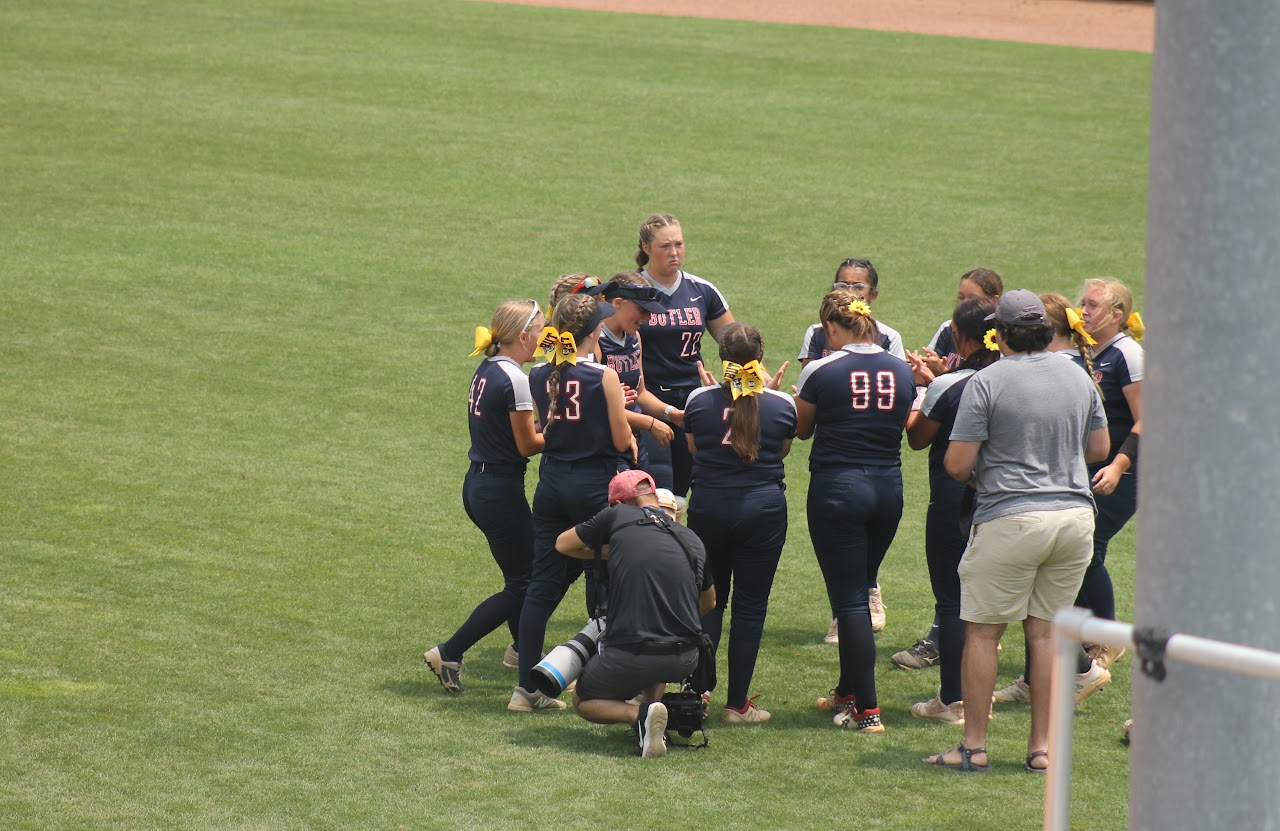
[685,323,796,725]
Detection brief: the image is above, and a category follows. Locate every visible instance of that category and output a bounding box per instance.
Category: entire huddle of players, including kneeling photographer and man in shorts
[424,214,1143,772]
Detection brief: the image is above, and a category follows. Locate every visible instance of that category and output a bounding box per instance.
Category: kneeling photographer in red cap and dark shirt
[556,470,716,758]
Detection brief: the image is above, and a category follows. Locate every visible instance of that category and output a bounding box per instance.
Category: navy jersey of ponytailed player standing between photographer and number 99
[685,387,796,489]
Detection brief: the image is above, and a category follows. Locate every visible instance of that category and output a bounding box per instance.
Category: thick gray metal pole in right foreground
[1129,0,1280,831]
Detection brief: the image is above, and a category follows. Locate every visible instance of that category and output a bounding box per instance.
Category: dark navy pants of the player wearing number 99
[808,465,902,709]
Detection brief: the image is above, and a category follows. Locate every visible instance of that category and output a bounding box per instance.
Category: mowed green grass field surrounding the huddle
[0,0,1151,831]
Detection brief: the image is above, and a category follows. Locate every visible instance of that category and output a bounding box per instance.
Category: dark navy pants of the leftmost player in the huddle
[440,462,534,661]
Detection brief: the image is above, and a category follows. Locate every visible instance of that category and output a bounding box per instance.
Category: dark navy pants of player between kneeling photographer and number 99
[689,483,787,709]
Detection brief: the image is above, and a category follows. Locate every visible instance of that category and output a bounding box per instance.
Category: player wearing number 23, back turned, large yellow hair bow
[507,294,631,712]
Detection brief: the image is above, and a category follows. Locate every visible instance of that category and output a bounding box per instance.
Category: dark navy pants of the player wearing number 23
[516,457,617,690]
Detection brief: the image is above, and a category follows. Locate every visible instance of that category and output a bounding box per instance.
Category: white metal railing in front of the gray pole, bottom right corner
[1044,607,1280,831]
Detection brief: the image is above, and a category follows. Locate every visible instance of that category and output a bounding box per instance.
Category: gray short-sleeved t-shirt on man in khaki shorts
[951,352,1107,522]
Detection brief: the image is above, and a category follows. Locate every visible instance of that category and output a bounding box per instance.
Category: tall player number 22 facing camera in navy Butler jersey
[635,214,733,497]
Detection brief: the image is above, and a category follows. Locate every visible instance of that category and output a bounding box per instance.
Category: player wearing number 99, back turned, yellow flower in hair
[796,289,915,732]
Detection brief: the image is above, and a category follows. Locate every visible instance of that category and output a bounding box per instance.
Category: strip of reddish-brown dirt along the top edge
[479,0,1156,52]
